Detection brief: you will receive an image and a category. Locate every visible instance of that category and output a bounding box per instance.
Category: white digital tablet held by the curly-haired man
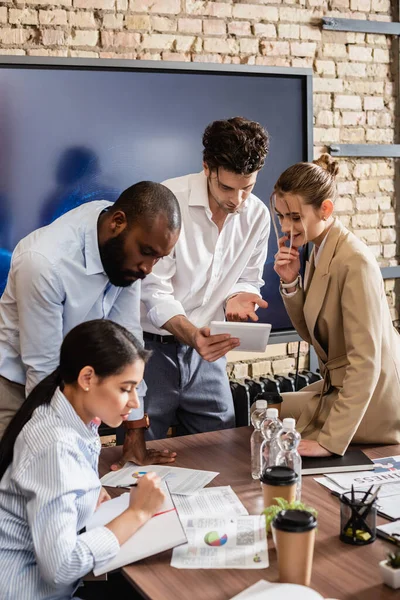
[210,321,271,352]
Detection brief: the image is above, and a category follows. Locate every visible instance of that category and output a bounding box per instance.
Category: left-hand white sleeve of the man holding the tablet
[142,254,186,328]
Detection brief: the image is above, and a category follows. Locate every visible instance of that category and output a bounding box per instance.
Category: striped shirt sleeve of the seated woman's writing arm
[18,442,120,585]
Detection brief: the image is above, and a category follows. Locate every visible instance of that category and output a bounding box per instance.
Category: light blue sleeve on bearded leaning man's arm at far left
[13,252,64,395]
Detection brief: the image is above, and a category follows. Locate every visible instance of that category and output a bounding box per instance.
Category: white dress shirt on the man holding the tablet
[142,172,270,335]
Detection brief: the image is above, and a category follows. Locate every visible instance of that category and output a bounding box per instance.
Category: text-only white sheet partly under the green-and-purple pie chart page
[174,485,249,518]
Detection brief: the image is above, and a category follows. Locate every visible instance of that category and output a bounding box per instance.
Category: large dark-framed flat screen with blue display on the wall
[0,58,311,331]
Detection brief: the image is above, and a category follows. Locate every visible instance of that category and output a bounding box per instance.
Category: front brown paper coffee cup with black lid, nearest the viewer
[272,510,317,585]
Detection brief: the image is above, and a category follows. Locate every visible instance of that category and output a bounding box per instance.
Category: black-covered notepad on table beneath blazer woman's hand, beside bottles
[301,449,375,475]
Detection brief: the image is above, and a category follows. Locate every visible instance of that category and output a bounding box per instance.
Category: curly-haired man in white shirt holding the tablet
[117,117,270,458]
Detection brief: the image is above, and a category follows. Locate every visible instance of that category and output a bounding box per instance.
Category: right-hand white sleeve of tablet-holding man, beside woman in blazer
[227,211,270,299]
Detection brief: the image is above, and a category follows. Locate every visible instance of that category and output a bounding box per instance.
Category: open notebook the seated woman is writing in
[86,483,187,576]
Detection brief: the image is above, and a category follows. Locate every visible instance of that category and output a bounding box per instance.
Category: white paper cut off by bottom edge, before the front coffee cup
[231,579,323,600]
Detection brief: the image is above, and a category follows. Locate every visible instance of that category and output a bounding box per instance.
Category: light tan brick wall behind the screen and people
[0,0,397,372]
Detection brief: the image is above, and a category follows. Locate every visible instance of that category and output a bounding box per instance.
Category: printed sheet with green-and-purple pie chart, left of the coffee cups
[171,515,269,569]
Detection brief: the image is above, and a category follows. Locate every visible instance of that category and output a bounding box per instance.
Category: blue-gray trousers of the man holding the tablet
[144,340,235,440]
